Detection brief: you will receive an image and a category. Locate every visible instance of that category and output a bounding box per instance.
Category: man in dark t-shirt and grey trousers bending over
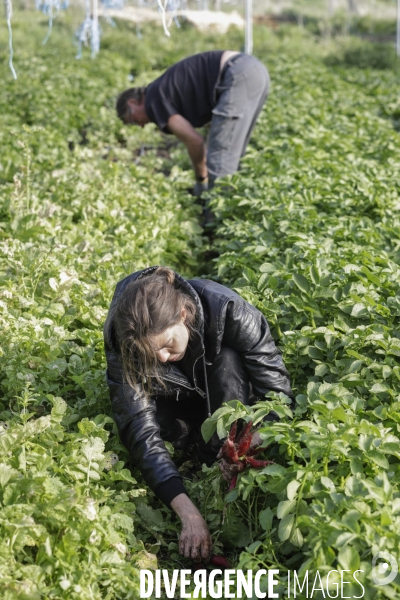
[116,50,269,195]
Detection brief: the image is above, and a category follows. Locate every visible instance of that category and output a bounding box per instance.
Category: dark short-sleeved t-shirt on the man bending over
[145,50,223,133]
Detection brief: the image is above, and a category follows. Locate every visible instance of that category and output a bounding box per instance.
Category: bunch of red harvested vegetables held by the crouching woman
[220,421,273,491]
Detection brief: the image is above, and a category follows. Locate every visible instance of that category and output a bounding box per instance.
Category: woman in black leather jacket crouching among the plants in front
[104,267,292,561]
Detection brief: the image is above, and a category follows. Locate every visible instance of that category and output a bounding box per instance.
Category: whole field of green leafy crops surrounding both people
[0,12,400,600]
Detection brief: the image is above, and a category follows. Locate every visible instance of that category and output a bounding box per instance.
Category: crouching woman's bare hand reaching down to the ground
[171,494,212,563]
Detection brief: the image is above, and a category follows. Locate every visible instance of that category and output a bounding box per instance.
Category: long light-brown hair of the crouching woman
[114,267,196,394]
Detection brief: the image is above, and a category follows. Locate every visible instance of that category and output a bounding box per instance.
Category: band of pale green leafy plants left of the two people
[0,12,219,600]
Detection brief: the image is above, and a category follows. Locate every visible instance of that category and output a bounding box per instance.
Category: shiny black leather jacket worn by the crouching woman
[104,267,292,502]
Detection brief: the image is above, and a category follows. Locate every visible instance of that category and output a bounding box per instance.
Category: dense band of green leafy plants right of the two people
[204,31,400,600]
